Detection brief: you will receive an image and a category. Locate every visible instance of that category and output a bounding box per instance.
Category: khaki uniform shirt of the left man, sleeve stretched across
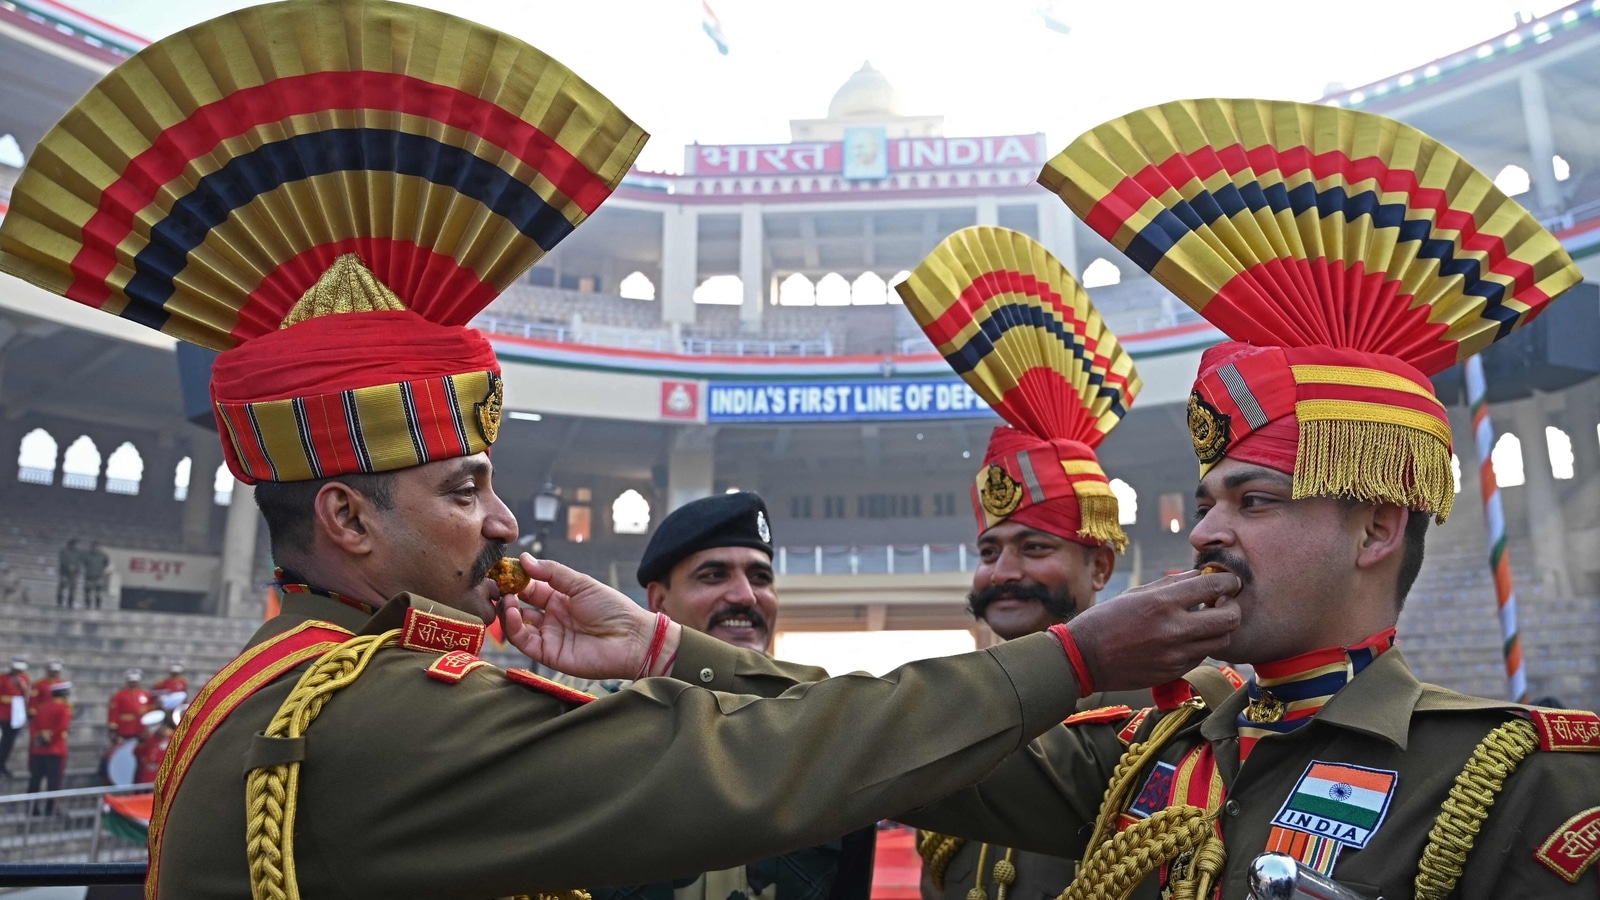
[158,594,1078,900]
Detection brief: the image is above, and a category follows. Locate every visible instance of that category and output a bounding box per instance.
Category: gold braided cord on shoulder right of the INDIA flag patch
[1416,719,1539,900]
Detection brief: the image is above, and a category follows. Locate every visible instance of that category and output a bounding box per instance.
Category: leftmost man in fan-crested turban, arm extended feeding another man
[0,0,1240,900]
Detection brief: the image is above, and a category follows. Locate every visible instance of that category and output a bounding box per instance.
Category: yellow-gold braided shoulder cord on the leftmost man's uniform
[245,629,589,900]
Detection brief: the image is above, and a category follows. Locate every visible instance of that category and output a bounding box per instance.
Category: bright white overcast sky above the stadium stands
[67,0,1563,171]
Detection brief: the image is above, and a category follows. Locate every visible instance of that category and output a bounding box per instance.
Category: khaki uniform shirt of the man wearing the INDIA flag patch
[899,649,1600,900]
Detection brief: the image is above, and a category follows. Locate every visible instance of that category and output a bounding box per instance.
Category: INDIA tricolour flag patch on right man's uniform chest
[1272,762,1400,850]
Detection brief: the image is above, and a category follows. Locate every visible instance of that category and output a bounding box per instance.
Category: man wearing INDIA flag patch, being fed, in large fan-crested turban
[909,99,1600,900]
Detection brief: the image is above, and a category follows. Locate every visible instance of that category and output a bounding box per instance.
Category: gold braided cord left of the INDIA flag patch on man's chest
[1058,700,1227,900]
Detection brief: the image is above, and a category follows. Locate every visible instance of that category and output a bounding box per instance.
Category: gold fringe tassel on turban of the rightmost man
[1294,418,1456,525]
